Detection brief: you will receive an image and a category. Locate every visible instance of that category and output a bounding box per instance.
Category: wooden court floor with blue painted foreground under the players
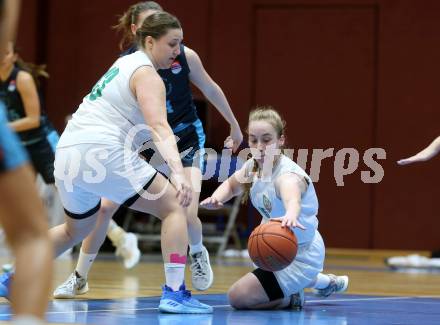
[0,249,440,325]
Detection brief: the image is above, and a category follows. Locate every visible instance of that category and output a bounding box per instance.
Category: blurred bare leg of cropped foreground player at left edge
[0,166,53,318]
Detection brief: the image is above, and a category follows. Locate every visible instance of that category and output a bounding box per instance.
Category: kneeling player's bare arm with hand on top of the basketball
[275,173,307,229]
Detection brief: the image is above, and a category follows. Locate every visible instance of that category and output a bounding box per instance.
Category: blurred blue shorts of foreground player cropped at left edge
[0,102,27,172]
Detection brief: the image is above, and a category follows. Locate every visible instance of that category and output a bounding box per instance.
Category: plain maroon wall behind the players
[18,0,440,249]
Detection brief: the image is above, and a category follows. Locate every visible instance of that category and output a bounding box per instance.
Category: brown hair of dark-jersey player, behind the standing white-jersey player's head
[113,1,163,50]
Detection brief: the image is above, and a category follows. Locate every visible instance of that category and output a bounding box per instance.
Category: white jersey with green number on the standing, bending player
[58,51,155,149]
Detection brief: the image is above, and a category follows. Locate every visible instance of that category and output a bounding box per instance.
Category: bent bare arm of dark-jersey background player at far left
[9,71,41,132]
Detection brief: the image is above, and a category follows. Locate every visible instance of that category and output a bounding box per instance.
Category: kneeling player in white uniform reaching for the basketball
[200,107,348,309]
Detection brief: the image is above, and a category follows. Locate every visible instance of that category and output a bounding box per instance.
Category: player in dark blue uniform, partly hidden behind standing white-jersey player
[53,1,243,299]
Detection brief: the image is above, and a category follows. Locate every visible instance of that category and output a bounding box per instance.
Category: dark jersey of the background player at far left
[0,67,53,145]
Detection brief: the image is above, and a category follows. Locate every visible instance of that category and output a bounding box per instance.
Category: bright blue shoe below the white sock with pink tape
[159,283,213,314]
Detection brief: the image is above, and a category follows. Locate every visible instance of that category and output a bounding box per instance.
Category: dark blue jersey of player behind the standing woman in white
[121,45,198,132]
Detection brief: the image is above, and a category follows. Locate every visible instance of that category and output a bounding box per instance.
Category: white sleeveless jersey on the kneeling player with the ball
[248,155,318,244]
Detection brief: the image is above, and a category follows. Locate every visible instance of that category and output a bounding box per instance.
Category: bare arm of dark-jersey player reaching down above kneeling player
[185,47,243,152]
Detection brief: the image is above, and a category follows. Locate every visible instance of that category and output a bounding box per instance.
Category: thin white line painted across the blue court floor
[0,296,435,317]
